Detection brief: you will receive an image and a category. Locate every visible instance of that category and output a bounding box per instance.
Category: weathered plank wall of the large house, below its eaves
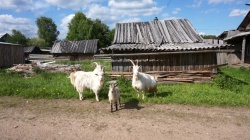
[112,53,217,72]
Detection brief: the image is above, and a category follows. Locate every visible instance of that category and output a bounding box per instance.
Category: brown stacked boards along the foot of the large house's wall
[106,70,216,83]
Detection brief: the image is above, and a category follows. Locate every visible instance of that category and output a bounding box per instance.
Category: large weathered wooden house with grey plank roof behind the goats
[101,19,234,73]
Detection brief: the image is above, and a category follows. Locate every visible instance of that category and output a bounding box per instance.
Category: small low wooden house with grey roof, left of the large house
[51,39,98,60]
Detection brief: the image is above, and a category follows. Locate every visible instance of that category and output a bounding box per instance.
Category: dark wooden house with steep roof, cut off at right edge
[218,11,250,64]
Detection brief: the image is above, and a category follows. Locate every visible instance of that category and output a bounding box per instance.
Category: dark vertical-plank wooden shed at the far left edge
[0,42,24,67]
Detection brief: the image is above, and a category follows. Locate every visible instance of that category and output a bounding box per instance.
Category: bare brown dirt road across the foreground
[0,97,250,140]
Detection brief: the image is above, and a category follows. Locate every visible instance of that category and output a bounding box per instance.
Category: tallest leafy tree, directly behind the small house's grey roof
[66,12,93,40]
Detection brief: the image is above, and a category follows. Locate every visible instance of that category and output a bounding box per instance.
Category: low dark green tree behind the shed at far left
[6,29,28,46]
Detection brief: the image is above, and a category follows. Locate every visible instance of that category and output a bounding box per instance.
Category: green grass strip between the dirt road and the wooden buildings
[0,61,250,107]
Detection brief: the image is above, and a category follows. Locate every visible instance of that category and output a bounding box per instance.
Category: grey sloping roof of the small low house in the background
[51,39,98,53]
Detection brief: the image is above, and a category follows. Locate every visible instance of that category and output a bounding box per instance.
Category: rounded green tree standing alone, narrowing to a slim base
[36,16,60,47]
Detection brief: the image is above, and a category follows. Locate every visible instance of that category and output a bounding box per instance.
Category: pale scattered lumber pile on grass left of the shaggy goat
[8,63,81,74]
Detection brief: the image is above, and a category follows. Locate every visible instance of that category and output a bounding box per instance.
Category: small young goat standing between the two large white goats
[108,83,121,112]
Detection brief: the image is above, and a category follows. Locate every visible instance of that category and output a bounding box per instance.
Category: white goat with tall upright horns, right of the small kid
[129,60,157,99]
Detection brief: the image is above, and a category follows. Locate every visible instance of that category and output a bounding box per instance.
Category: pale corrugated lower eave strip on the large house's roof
[102,43,232,51]
